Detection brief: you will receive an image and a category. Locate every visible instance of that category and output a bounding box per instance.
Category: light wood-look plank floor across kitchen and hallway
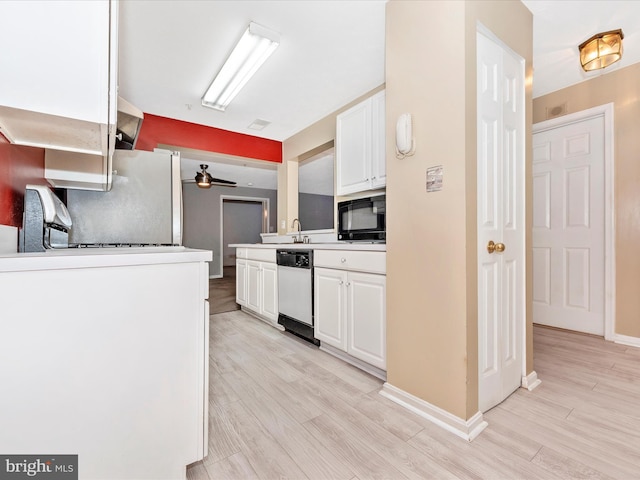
[187,311,640,480]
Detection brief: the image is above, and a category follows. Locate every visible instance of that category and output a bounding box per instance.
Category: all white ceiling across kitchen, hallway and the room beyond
[119,0,640,188]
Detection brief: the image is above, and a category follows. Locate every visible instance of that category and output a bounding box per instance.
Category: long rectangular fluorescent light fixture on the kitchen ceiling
[202,22,280,112]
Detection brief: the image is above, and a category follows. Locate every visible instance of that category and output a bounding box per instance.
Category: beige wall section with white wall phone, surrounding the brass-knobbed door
[386,0,532,419]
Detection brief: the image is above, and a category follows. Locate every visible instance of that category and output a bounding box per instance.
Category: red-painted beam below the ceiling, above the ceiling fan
[136,113,282,163]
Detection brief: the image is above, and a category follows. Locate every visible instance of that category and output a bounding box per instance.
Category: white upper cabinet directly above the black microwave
[336,90,386,195]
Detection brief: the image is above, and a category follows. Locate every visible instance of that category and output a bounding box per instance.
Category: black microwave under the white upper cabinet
[338,195,387,243]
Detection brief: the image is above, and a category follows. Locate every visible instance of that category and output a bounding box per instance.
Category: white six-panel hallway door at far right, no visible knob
[533,116,605,335]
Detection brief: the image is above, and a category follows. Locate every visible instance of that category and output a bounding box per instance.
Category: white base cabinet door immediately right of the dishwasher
[314,268,347,352]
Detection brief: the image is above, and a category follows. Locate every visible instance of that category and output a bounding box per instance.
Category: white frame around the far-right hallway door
[532,103,616,341]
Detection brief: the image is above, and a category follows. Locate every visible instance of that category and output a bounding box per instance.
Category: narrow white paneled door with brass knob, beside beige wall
[477,33,525,412]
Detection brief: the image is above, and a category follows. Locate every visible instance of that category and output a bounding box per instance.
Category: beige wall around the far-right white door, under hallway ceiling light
[533,63,640,337]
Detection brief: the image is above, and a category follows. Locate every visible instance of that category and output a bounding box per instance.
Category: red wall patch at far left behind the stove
[0,134,47,227]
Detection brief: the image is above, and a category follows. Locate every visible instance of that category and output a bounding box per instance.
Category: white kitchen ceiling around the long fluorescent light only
[119,0,385,141]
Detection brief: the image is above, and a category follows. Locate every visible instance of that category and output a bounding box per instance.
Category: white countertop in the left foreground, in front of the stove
[0,247,212,273]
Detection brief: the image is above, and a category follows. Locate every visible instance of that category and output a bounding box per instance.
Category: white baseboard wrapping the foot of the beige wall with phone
[380,383,488,442]
